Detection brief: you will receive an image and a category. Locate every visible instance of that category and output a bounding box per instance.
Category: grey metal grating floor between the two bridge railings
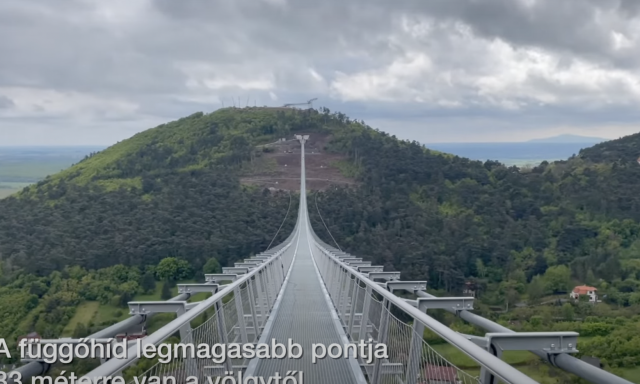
[253,217,358,384]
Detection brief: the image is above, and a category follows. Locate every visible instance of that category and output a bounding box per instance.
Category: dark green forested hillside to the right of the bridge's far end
[317,129,640,299]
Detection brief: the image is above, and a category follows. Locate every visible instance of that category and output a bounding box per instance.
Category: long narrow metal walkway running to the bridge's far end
[247,136,366,384]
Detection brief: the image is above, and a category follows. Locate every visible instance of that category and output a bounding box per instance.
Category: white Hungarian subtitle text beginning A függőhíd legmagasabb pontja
[0,339,388,384]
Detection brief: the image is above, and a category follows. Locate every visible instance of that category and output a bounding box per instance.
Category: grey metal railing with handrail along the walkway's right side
[314,235,537,384]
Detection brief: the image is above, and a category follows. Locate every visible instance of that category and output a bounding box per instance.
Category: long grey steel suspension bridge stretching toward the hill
[8,136,630,384]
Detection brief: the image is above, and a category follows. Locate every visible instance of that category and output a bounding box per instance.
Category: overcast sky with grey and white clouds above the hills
[0,0,640,146]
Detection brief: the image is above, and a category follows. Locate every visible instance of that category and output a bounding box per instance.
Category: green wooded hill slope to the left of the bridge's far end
[0,108,356,276]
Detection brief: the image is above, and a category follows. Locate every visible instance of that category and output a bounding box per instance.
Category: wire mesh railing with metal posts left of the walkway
[80,236,295,384]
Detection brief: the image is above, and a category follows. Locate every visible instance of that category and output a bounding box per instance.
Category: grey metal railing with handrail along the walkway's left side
[79,226,297,383]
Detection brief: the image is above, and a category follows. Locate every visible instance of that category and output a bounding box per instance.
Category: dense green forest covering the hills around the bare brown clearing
[0,108,640,380]
